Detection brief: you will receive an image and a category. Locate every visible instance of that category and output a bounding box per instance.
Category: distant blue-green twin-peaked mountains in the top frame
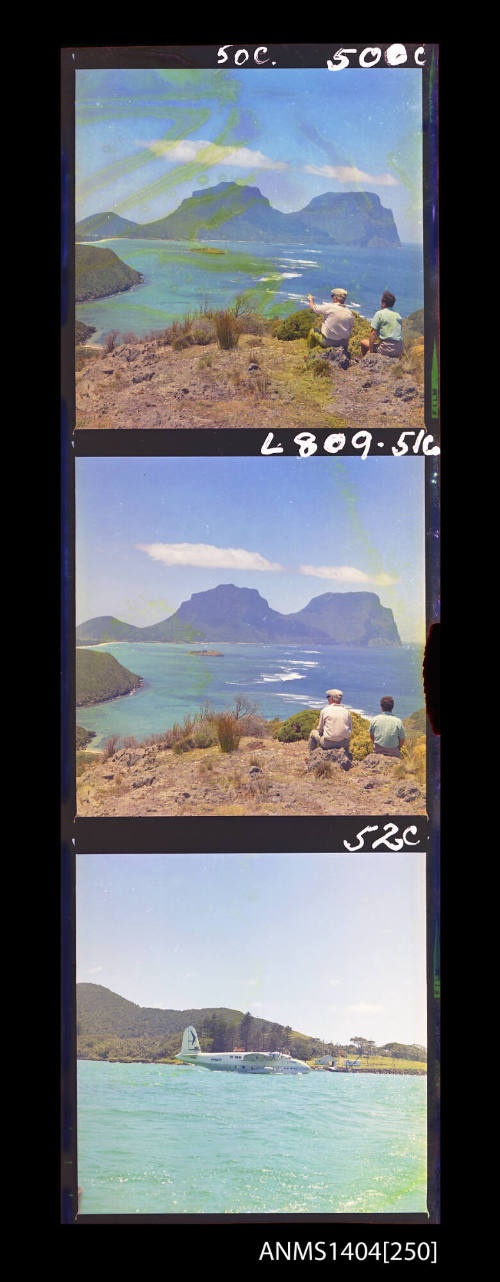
[76,182,400,247]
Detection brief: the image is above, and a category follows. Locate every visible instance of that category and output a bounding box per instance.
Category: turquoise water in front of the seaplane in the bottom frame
[78,1061,427,1214]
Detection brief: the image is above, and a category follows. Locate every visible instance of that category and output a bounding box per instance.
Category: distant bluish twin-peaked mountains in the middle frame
[76,583,401,646]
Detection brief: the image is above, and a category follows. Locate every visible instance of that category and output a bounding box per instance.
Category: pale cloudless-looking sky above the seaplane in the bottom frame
[77,853,427,1045]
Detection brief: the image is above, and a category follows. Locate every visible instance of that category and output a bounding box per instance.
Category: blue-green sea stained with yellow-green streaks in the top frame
[76,238,423,342]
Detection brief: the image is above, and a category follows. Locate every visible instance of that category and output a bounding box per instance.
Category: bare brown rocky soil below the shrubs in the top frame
[76,335,424,432]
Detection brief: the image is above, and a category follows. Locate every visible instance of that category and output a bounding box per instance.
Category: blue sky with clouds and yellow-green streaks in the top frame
[76,68,422,242]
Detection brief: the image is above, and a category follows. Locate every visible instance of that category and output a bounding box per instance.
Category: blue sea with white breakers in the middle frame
[77,641,424,747]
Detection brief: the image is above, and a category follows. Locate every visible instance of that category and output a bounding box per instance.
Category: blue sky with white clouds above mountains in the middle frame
[76,455,424,642]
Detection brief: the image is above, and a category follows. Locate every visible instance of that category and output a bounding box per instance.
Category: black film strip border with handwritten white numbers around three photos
[62,42,441,1261]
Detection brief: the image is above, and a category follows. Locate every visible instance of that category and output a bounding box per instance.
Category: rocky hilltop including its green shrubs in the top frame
[76,307,424,435]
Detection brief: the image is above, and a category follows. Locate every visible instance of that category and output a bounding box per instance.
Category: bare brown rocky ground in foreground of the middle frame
[77,737,426,817]
